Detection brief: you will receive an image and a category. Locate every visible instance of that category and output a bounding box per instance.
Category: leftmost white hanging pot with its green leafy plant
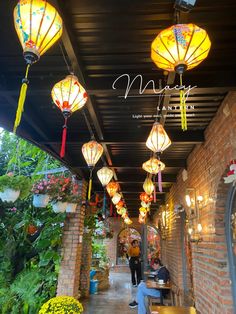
[0,172,31,202]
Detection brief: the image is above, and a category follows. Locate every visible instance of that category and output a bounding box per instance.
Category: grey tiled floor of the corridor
[82,272,137,314]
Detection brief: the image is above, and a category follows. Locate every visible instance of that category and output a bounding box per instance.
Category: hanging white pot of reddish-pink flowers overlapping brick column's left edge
[48,176,71,213]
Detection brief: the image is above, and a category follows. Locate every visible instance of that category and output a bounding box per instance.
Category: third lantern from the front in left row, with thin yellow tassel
[82,140,103,200]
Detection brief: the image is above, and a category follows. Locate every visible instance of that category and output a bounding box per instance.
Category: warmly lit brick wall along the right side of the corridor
[157,92,236,314]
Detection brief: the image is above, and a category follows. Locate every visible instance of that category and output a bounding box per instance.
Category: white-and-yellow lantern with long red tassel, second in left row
[51,75,88,158]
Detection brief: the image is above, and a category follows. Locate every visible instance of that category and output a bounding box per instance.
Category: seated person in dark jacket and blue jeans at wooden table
[129,258,170,314]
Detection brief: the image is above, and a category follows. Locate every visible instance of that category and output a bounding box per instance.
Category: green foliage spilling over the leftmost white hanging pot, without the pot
[0,173,32,199]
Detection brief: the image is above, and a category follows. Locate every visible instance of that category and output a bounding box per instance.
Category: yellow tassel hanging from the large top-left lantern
[13,64,30,134]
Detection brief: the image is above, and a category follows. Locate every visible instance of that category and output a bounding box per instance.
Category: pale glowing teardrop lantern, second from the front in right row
[146,122,171,153]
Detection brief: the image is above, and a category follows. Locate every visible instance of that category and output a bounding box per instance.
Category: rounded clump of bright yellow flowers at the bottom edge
[39,296,83,314]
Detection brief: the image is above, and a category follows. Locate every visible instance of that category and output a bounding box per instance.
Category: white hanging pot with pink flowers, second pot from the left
[32,179,50,208]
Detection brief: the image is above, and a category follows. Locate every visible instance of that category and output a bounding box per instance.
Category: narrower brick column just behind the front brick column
[80,233,92,297]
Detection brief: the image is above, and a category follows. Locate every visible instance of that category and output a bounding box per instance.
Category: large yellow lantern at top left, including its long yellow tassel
[13,0,62,133]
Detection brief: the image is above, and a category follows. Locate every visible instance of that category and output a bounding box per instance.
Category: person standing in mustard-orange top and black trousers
[128,240,141,287]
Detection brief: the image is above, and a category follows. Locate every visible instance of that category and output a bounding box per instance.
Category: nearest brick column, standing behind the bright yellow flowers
[57,181,87,298]
